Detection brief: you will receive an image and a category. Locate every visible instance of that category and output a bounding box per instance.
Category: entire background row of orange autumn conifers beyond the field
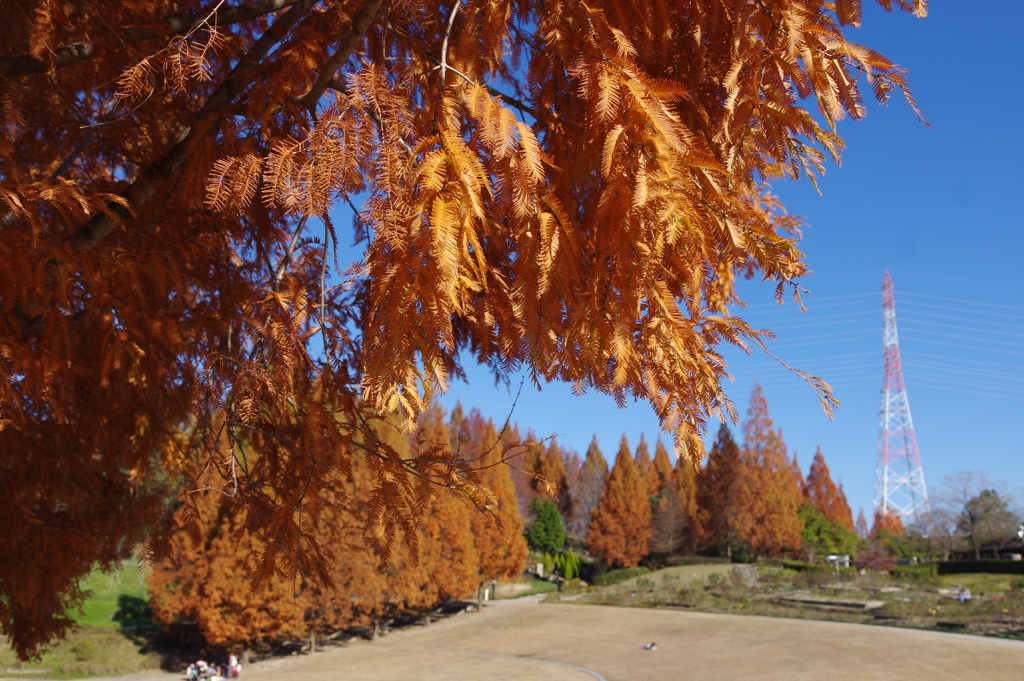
[150,387,901,650]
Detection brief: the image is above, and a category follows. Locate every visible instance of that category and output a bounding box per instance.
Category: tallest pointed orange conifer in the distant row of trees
[735,382,804,557]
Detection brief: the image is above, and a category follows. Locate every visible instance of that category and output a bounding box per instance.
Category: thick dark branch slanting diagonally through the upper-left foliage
[71,0,315,252]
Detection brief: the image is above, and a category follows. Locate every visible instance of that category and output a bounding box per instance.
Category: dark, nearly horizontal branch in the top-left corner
[0,0,299,78]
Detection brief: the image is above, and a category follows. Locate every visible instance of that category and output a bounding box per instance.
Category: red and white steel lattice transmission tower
[874,270,929,525]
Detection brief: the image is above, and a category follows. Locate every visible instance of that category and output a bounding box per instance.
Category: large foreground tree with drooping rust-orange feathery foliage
[0,0,925,656]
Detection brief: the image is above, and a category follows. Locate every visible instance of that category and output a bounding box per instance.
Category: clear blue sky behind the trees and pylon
[339,0,1024,518]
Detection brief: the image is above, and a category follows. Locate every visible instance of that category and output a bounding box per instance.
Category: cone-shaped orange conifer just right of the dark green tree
[587,435,653,567]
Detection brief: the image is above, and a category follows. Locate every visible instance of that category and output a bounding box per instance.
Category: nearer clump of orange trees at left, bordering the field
[150,405,526,647]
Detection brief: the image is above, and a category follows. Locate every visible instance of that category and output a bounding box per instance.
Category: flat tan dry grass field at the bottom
[68,597,1024,681]
